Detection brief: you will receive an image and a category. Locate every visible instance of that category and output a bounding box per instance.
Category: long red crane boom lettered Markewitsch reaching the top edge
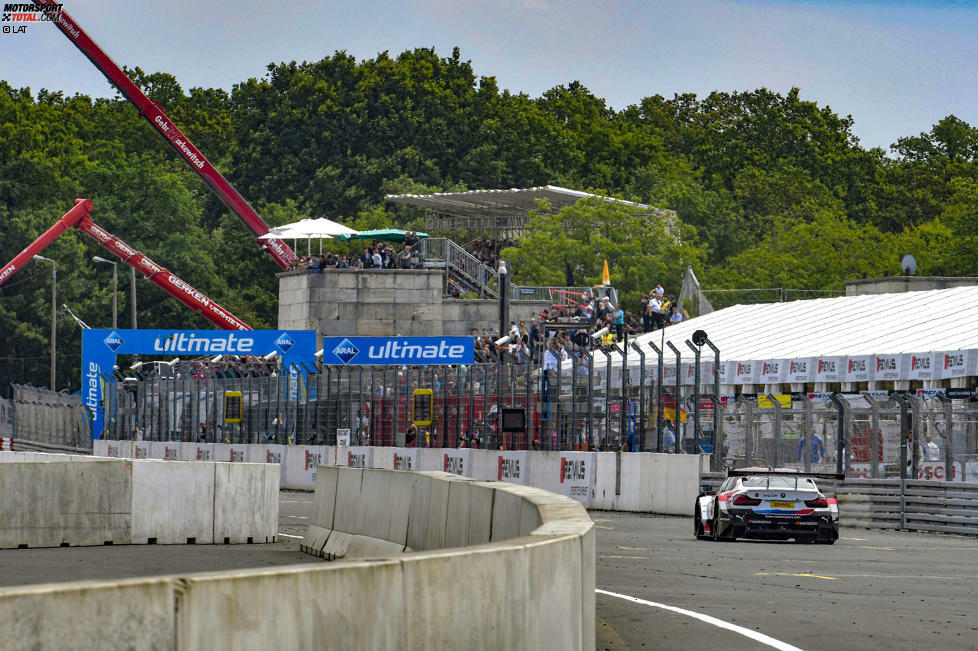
[33,0,296,269]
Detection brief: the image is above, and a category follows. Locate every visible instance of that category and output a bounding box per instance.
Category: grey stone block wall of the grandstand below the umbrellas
[278,269,550,337]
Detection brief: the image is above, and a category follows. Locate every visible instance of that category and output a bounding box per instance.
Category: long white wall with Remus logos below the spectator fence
[95,440,710,515]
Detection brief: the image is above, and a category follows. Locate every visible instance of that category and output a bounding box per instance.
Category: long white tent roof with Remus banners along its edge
[598,287,978,384]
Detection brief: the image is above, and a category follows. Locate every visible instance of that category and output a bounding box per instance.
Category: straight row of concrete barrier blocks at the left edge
[0,452,279,548]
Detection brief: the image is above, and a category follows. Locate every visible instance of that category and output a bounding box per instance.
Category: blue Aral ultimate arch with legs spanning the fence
[82,329,316,438]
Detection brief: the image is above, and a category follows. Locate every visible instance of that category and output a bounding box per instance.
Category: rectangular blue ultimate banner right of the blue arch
[323,337,475,366]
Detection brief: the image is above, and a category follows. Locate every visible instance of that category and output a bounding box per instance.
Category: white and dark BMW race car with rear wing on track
[693,468,839,545]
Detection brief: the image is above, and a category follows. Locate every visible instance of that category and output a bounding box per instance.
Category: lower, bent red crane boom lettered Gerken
[0,199,252,330]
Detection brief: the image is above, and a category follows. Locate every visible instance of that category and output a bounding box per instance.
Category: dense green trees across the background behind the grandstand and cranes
[0,48,978,387]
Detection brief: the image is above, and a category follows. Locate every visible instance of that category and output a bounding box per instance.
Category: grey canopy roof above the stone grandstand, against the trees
[385,185,658,224]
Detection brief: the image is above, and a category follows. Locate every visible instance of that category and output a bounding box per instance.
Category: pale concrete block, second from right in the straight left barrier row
[132,459,215,545]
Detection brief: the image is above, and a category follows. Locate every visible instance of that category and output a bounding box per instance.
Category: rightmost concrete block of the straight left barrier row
[212,463,280,544]
